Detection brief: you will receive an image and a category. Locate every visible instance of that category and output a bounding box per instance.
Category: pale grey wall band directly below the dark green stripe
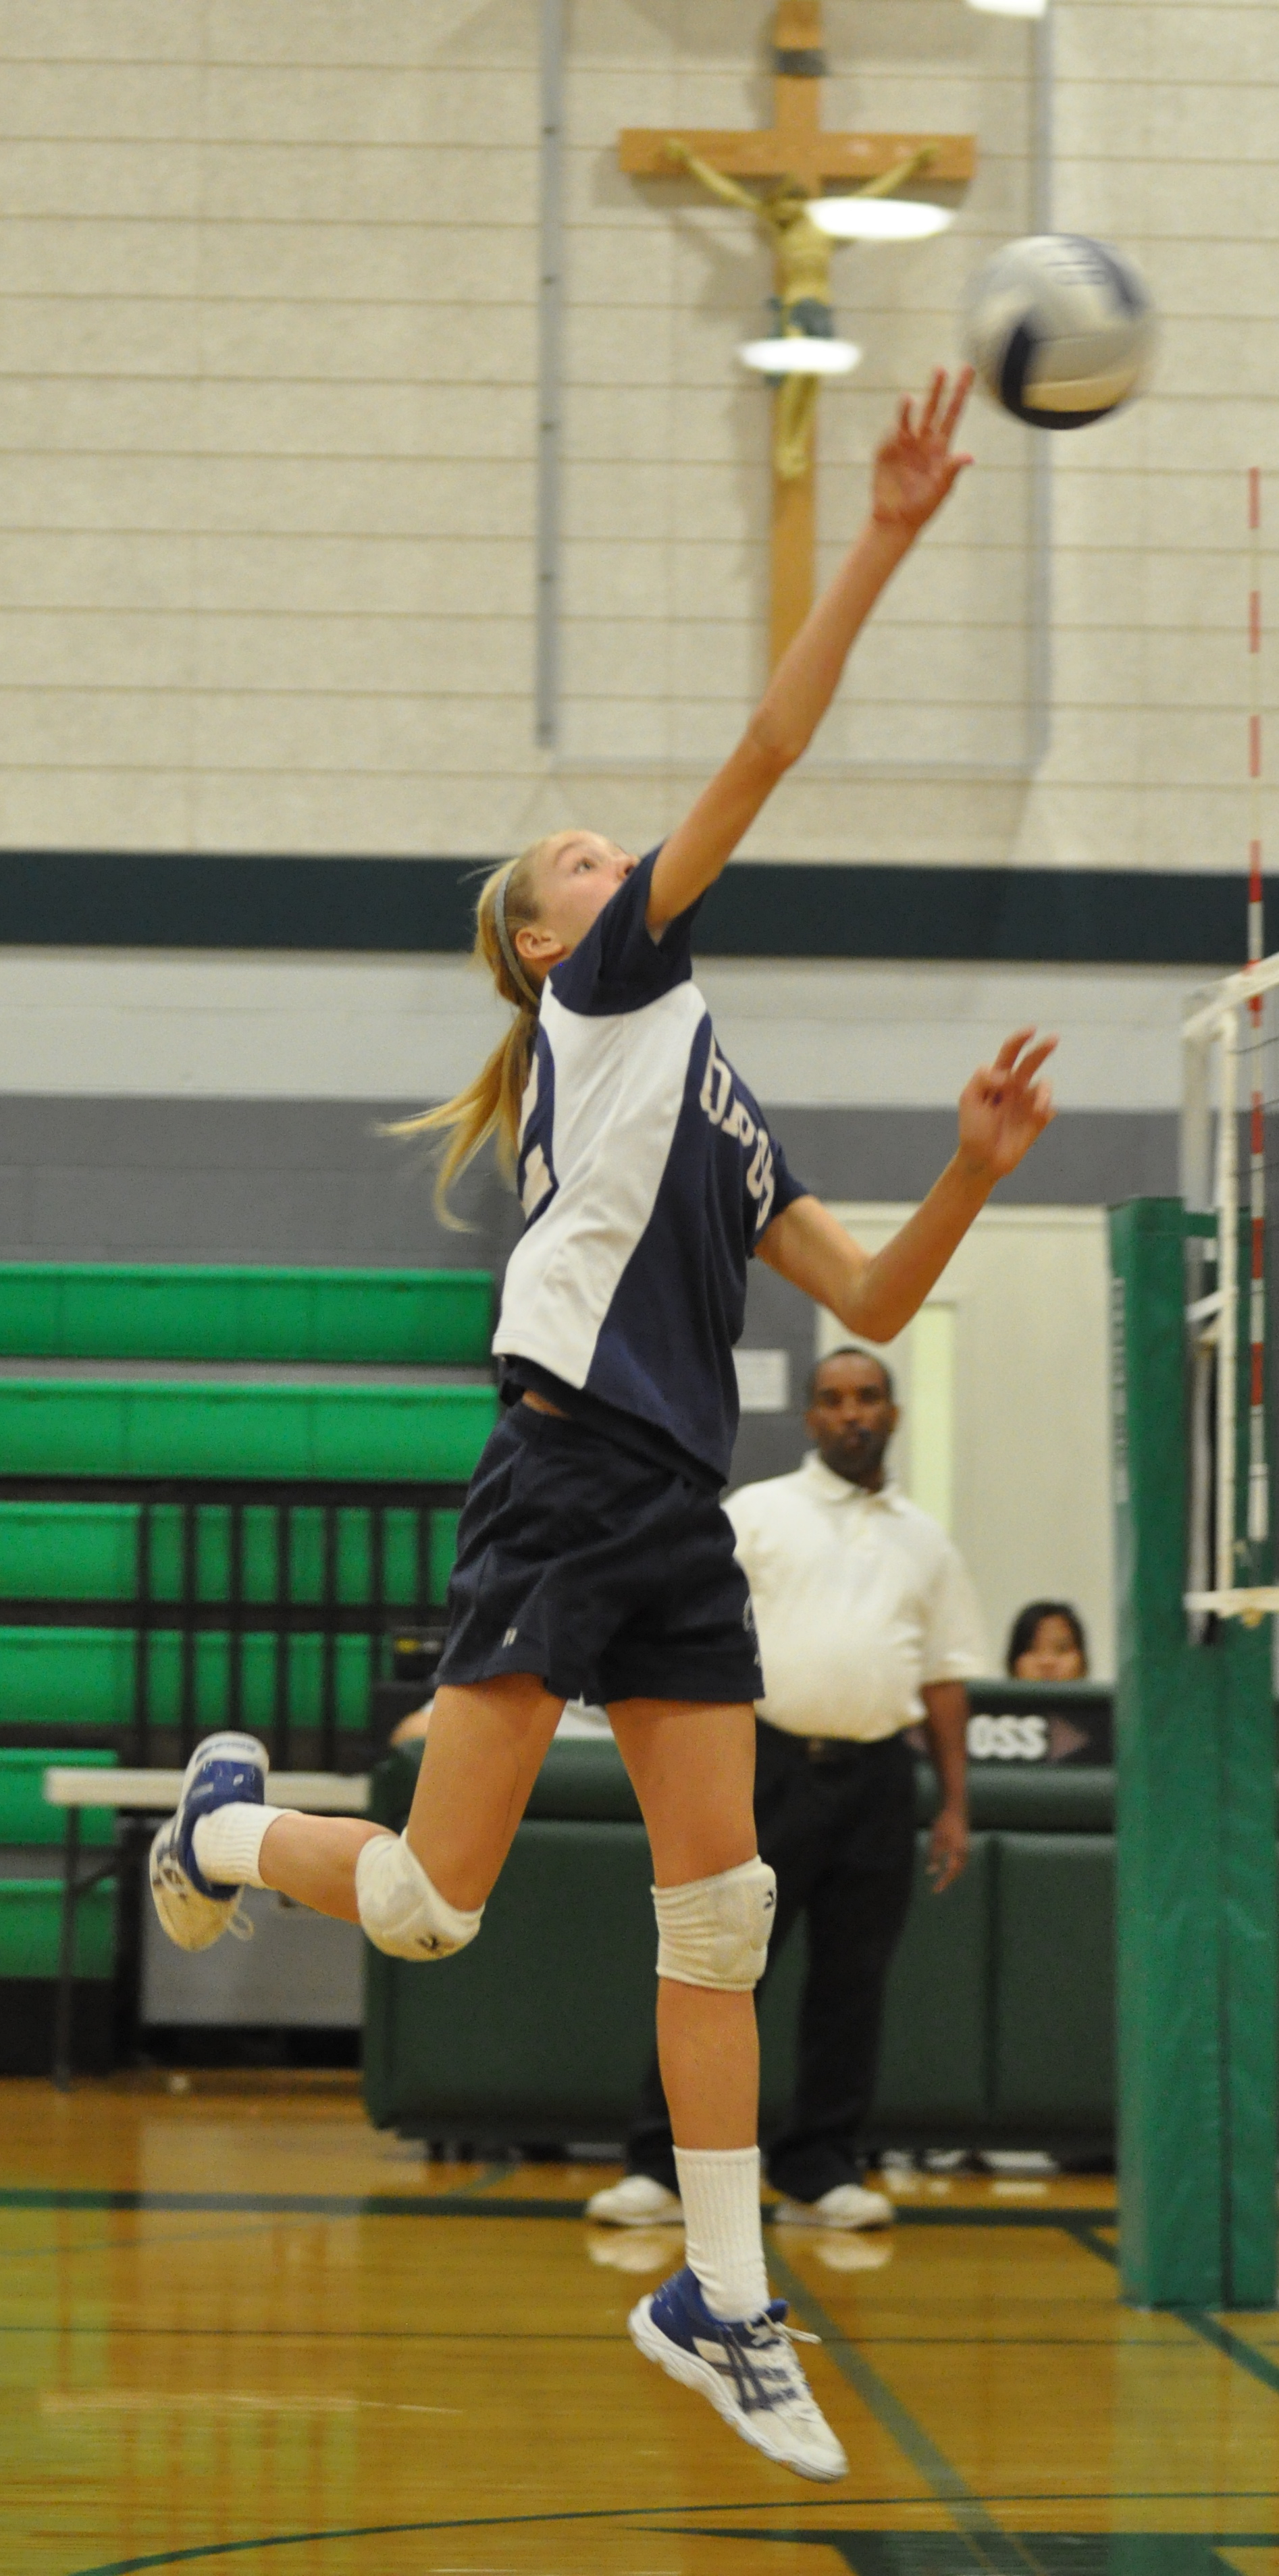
[0,948,1197,1110]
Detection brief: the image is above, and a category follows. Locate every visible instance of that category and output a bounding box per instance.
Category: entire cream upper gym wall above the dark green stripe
[0,0,1263,868]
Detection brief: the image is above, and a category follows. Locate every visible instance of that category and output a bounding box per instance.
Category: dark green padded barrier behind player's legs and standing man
[363,1731,1114,2149]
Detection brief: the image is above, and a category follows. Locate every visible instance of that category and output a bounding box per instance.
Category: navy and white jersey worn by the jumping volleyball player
[492,850,804,1484]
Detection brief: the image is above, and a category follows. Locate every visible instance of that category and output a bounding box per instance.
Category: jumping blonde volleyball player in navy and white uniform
[152,373,1052,2478]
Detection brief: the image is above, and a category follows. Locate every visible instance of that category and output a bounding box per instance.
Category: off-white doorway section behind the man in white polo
[817,1206,1114,1677]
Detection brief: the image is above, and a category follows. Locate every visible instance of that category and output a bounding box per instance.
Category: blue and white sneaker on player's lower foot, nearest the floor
[629,2270,848,2478]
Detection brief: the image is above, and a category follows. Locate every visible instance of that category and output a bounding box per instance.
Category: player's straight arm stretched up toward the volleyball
[647,369,972,932]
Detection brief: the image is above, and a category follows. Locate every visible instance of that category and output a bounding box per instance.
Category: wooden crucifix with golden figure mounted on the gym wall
[619,0,977,665]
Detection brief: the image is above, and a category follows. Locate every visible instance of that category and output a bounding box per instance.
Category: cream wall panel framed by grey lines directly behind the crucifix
[565,0,1031,772]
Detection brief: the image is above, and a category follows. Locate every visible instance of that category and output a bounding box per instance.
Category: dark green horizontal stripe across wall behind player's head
[0,850,1248,966]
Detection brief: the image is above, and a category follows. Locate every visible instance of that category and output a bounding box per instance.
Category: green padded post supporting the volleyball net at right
[1112,1198,1276,2308]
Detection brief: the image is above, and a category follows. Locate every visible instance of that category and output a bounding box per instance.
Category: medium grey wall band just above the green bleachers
[0,1092,1176,1262]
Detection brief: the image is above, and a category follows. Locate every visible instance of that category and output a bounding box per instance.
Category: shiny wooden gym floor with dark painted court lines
[0,2076,1279,2576]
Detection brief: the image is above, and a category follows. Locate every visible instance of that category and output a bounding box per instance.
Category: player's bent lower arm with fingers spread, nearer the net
[758,1028,1058,1342]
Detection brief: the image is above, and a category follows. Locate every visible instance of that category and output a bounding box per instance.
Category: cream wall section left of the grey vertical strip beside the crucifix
[0,0,546,850]
